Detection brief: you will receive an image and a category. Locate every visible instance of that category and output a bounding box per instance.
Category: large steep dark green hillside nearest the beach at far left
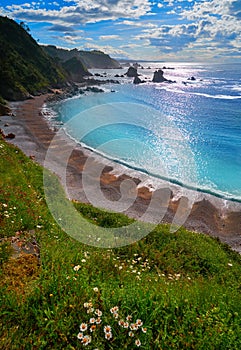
[0,17,66,100]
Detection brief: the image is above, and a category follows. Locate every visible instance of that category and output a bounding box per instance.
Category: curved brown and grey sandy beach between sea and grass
[0,95,241,253]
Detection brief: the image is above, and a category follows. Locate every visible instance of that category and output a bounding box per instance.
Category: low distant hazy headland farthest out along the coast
[43,45,120,69]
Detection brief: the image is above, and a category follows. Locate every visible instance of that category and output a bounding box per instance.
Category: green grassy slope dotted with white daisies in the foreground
[0,135,241,350]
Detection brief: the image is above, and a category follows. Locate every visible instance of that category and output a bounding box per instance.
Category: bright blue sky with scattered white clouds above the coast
[0,0,241,62]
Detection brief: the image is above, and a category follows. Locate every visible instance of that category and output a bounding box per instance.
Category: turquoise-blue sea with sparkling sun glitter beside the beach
[47,62,241,202]
